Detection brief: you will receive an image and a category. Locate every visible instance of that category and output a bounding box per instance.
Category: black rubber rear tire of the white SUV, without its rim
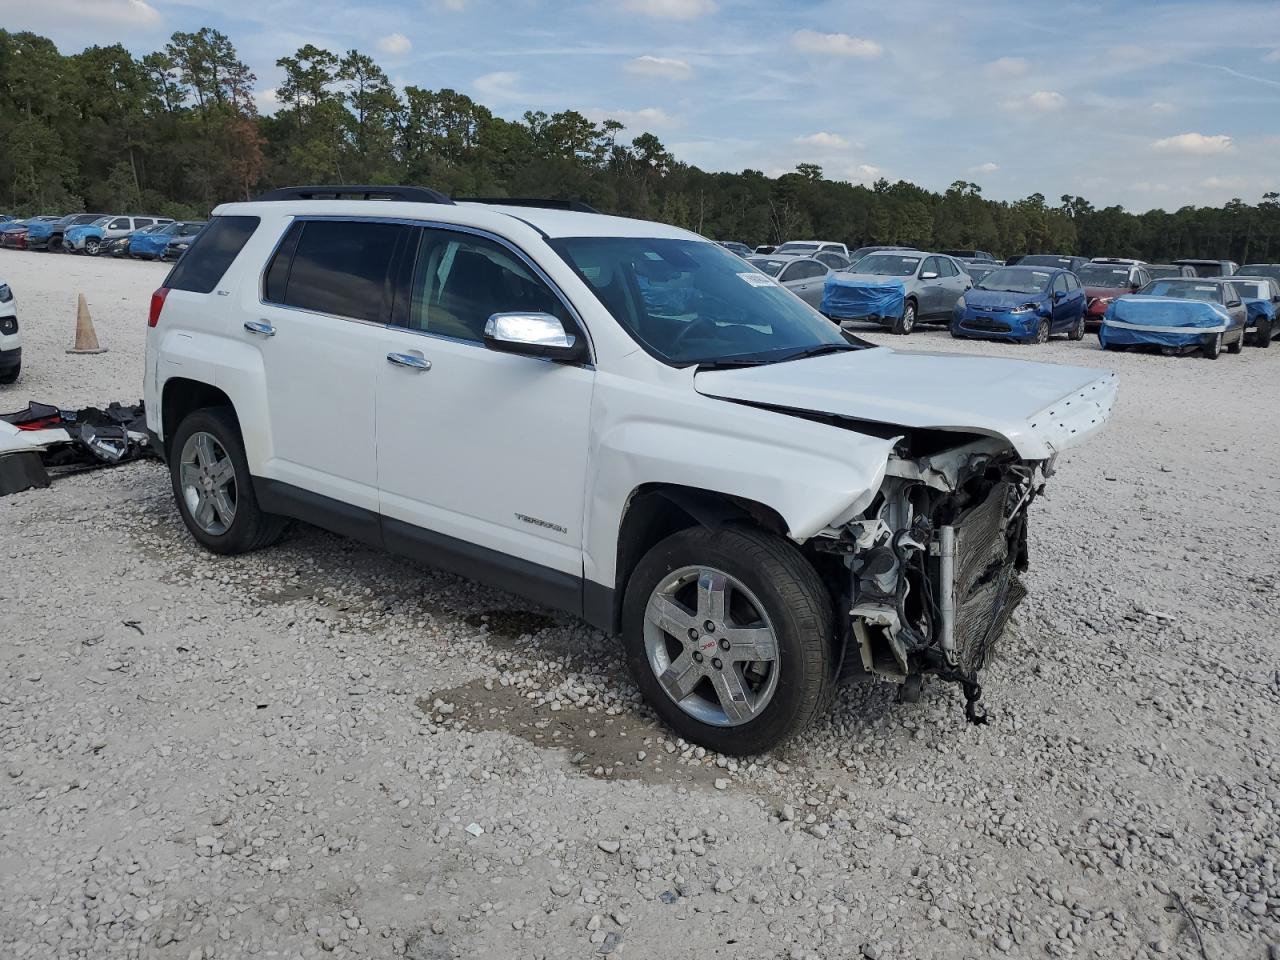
[169,407,288,554]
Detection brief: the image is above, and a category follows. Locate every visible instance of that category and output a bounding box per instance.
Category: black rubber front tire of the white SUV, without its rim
[622,526,835,755]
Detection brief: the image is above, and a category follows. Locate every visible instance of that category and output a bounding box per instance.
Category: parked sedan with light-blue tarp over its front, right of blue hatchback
[1098,278,1247,360]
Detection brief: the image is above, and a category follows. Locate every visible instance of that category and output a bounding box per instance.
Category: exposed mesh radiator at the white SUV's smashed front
[955,483,1027,676]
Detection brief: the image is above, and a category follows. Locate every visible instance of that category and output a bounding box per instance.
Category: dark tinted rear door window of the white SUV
[266,220,410,323]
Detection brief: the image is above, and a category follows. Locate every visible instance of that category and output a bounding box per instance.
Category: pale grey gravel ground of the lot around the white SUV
[0,251,1280,960]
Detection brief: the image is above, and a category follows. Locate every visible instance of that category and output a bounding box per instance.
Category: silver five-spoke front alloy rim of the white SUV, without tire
[644,566,780,727]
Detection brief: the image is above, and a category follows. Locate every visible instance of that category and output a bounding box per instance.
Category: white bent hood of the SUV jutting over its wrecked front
[694,347,1116,460]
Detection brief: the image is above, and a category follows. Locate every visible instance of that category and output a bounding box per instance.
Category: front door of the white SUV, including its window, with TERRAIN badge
[376,228,595,608]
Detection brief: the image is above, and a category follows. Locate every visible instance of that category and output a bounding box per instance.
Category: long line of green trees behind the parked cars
[0,27,1280,262]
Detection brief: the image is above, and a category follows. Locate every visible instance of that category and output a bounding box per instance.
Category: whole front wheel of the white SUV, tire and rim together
[622,527,833,754]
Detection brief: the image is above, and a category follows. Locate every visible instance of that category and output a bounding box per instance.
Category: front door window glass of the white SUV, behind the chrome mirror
[407,228,573,343]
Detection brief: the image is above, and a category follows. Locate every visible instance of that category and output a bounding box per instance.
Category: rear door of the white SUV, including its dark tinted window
[250,219,412,519]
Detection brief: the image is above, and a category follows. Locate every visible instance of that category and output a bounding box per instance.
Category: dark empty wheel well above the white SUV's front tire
[612,484,787,632]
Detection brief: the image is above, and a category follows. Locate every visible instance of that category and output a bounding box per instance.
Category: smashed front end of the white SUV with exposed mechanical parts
[818,434,1052,723]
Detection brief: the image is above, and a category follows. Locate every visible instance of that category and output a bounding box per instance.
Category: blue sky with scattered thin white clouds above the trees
[10,0,1280,211]
